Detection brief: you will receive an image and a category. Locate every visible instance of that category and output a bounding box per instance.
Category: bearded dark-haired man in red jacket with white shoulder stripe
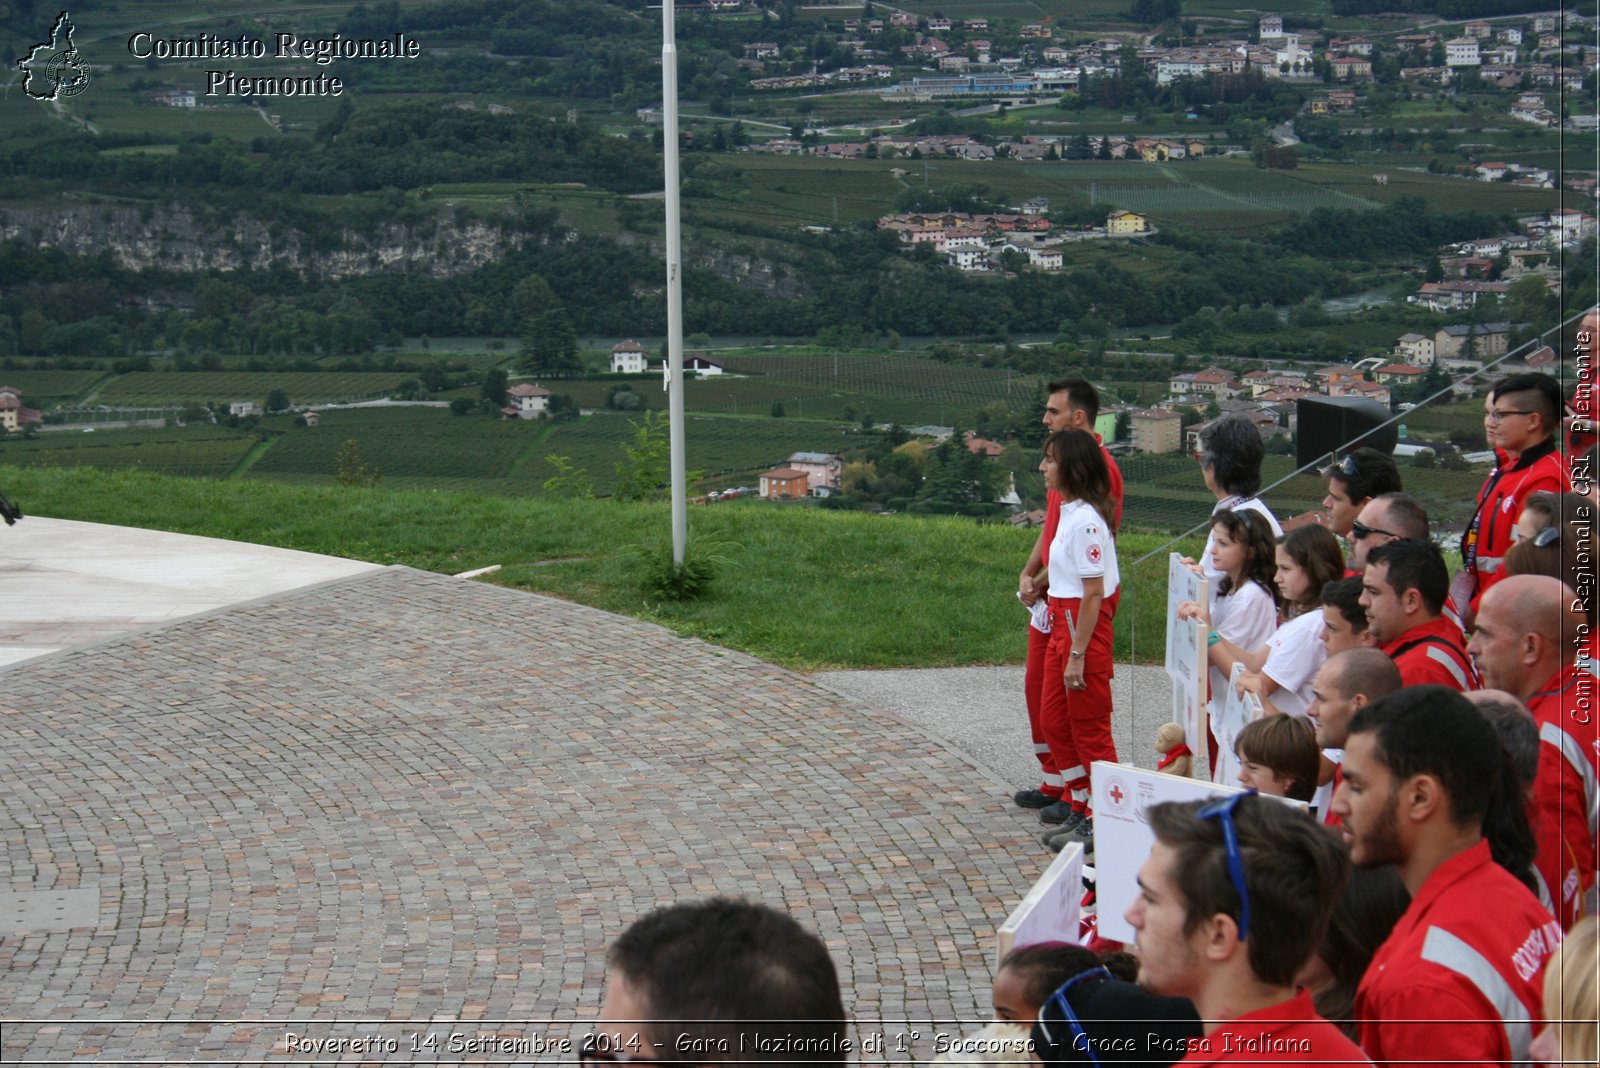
[1333,686,1562,1066]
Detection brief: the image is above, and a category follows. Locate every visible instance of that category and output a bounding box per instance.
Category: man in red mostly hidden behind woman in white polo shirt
[1011,379,1122,823]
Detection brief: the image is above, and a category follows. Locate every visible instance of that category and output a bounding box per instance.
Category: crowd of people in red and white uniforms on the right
[1014,374,1600,1063]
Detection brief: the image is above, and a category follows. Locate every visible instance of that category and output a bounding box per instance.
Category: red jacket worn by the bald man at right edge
[1528,667,1600,929]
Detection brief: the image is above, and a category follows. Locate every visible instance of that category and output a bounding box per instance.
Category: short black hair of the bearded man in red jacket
[1350,686,1506,828]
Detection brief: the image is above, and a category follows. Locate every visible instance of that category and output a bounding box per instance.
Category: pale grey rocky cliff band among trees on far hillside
[0,205,528,278]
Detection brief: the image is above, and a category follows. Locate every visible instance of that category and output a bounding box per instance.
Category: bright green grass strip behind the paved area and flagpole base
[0,467,1198,670]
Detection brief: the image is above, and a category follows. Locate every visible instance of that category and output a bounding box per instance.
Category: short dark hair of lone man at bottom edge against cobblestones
[608,897,845,1065]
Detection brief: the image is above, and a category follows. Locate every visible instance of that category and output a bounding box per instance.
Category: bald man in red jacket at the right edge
[1467,576,1600,929]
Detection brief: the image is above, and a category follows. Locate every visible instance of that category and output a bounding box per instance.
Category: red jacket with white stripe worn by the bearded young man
[1355,839,1562,1068]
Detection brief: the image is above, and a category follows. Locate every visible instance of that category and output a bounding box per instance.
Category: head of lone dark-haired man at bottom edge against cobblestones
[581,897,853,1066]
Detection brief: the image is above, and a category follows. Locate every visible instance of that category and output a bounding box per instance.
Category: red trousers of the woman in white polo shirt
[1038,595,1117,811]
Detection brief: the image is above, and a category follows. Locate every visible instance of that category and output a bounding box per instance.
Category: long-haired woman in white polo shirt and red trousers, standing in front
[1038,430,1122,849]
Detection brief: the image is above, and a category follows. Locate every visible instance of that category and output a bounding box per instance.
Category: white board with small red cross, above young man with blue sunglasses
[1093,761,1243,942]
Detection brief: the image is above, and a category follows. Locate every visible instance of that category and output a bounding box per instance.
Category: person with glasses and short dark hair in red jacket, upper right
[1451,373,1573,609]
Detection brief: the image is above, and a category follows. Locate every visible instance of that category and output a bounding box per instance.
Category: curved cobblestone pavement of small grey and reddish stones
[0,568,1050,1063]
